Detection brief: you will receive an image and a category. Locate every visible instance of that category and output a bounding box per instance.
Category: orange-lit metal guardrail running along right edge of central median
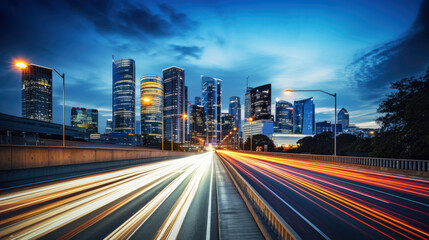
[217,154,302,240]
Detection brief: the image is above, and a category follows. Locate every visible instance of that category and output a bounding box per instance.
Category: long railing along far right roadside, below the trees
[239,151,429,172]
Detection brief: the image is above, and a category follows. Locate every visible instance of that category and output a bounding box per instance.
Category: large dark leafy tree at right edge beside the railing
[371,68,429,159]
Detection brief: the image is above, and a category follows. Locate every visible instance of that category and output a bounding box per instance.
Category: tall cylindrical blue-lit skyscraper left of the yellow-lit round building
[112,59,136,134]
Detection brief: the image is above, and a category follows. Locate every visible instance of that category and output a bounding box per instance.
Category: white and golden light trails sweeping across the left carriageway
[0,154,213,239]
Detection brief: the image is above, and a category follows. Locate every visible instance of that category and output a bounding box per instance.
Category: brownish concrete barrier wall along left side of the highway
[0,145,190,171]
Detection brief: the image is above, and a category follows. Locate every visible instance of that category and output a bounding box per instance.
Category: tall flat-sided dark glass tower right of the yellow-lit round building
[162,67,186,143]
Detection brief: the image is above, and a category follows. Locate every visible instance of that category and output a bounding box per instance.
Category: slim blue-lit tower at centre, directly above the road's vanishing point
[201,76,222,145]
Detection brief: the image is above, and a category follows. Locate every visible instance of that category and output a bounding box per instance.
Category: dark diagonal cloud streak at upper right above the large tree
[346,0,429,99]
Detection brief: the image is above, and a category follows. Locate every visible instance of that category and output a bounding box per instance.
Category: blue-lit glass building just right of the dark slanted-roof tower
[275,100,293,133]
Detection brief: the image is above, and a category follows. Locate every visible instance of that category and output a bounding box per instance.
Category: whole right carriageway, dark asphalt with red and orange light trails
[218,151,429,239]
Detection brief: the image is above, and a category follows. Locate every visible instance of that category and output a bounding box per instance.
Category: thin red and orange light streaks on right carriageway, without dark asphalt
[219,151,429,239]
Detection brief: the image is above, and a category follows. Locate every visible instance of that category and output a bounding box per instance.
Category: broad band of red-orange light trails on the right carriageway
[218,151,429,239]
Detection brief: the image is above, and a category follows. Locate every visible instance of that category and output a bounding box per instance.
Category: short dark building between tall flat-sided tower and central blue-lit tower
[189,104,207,145]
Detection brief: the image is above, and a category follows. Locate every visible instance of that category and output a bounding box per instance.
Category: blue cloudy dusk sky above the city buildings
[0,1,429,133]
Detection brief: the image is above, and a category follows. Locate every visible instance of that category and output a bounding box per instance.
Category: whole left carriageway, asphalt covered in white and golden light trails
[0,152,218,239]
